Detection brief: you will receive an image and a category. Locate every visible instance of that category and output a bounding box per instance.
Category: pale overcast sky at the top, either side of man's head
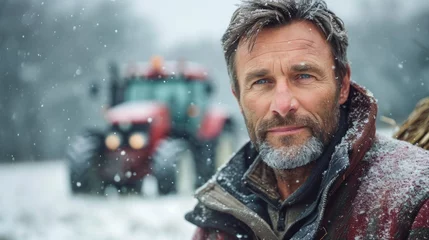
[136,0,429,47]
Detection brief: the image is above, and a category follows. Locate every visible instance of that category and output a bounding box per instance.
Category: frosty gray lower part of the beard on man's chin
[259,136,323,170]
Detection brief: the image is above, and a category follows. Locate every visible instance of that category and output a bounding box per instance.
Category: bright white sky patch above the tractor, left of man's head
[137,0,348,47]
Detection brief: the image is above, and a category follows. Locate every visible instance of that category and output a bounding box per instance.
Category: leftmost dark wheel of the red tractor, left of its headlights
[66,132,104,195]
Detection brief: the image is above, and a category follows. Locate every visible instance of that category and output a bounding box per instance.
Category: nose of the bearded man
[270,81,298,117]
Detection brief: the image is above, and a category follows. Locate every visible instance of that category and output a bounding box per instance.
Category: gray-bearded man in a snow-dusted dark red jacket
[186,0,429,240]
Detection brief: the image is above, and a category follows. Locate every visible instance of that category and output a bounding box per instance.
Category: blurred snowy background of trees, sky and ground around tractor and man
[0,0,429,240]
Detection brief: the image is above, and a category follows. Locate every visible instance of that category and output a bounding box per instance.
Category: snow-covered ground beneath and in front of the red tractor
[0,161,196,240]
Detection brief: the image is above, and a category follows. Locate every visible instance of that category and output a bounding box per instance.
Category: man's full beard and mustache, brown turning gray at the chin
[245,101,340,170]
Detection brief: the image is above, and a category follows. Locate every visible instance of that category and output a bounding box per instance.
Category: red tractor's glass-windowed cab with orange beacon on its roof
[119,59,212,137]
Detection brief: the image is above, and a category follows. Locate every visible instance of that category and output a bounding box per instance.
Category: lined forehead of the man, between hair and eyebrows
[235,21,332,67]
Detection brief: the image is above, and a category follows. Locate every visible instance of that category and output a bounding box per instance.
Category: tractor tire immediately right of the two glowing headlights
[152,139,185,196]
